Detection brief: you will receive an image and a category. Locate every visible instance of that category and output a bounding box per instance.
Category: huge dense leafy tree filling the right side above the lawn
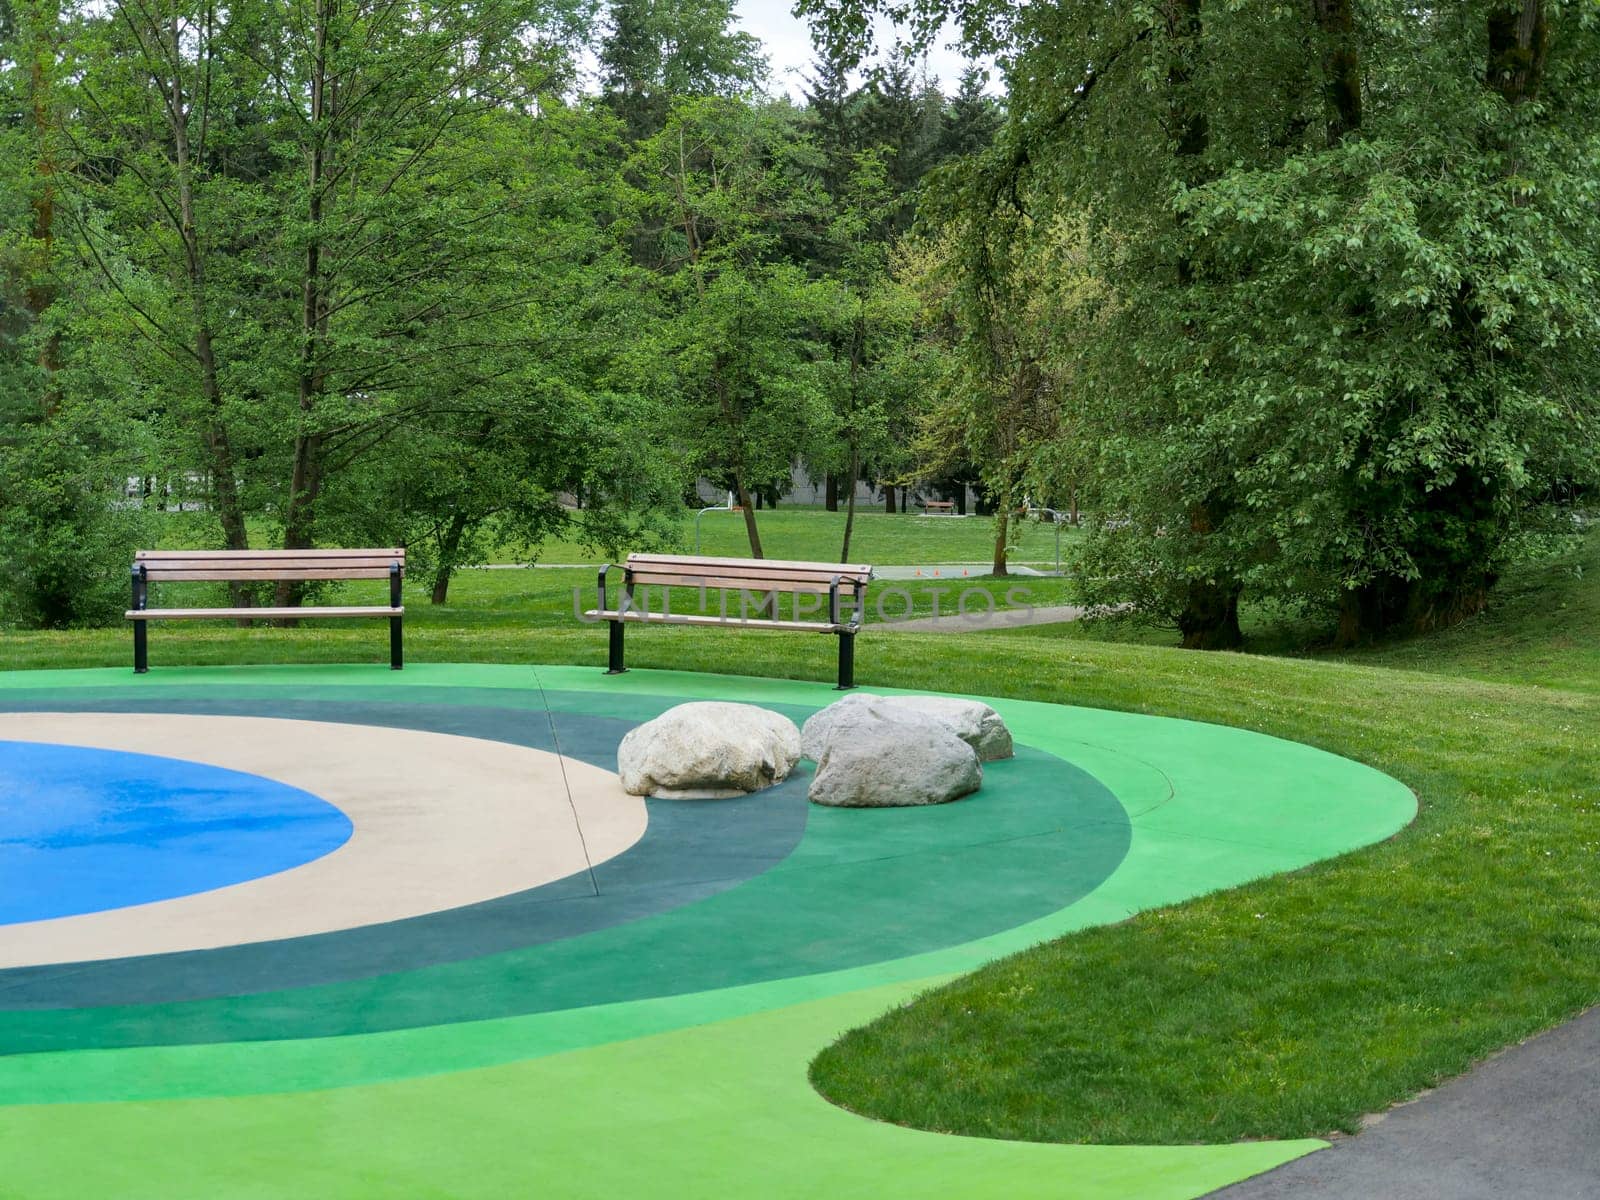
[803,0,1600,646]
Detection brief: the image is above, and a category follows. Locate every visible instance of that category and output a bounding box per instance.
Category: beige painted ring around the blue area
[0,712,646,968]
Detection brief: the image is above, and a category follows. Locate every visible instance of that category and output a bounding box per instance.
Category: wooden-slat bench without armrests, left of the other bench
[126,549,405,675]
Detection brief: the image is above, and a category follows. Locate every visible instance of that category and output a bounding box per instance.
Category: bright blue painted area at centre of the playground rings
[0,741,354,925]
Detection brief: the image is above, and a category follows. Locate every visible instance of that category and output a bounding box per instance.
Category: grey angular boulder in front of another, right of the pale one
[810,696,984,808]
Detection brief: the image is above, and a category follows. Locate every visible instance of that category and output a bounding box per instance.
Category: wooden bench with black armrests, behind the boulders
[584,554,872,690]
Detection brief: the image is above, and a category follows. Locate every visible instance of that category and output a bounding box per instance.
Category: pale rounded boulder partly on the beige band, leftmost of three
[616,701,800,798]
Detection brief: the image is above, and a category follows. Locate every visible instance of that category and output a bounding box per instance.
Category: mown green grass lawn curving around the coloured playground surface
[0,510,1600,1142]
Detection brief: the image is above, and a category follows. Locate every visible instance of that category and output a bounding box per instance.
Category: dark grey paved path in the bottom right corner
[1211,1008,1600,1200]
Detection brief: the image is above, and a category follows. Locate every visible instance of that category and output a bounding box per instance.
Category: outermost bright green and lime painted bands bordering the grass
[0,666,1414,1200]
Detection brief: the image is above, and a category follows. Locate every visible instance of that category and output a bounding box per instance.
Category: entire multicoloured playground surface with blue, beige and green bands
[0,666,1414,1200]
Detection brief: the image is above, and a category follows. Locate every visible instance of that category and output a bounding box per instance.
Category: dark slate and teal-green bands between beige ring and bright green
[0,686,1128,1053]
